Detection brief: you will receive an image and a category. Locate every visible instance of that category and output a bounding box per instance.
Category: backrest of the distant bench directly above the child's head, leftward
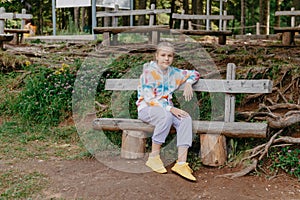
[96,4,171,26]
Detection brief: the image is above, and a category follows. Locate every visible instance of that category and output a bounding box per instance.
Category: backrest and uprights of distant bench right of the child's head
[172,11,234,31]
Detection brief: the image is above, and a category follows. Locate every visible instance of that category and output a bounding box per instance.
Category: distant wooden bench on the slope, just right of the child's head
[171,11,234,45]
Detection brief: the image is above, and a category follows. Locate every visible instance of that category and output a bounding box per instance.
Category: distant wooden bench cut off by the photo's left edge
[0,7,32,46]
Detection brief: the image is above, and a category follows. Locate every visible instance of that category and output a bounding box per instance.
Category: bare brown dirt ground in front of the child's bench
[1,159,300,200]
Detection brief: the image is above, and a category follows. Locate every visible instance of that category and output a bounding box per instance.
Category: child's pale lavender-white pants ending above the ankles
[138,106,193,147]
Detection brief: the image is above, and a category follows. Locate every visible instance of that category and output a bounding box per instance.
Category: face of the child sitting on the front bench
[156,47,174,70]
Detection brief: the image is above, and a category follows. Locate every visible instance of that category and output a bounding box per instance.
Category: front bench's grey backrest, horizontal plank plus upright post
[105,63,273,122]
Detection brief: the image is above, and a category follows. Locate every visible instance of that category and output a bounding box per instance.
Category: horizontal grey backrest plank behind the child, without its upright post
[105,79,273,94]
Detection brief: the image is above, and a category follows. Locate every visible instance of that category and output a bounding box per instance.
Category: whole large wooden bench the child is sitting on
[93,63,272,166]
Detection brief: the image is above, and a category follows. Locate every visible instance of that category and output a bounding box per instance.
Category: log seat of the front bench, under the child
[93,118,267,138]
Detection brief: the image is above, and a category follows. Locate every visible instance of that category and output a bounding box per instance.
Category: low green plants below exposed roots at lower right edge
[270,146,300,179]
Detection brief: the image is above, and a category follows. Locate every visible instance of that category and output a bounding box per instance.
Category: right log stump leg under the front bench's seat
[200,134,227,167]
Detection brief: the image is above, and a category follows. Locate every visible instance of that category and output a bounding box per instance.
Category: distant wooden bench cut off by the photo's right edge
[274,8,300,45]
